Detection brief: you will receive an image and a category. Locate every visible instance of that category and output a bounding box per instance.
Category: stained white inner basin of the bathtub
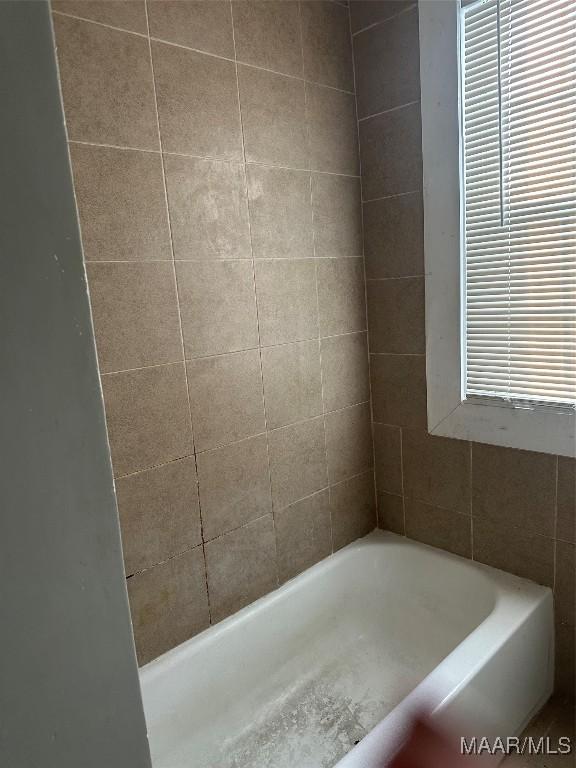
[142,534,494,768]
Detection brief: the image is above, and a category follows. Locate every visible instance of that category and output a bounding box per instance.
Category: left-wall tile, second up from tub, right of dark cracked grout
[196,435,272,541]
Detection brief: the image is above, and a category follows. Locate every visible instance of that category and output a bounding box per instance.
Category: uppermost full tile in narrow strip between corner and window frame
[354,6,420,118]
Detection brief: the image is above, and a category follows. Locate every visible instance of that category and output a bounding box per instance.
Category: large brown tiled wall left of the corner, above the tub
[52,0,376,664]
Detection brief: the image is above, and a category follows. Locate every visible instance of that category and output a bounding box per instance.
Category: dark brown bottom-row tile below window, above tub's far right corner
[473,517,554,586]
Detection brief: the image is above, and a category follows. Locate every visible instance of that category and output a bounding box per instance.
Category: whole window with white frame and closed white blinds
[420,0,576,455]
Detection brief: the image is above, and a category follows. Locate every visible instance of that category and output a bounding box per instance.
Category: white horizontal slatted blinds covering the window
[460,0,576,406]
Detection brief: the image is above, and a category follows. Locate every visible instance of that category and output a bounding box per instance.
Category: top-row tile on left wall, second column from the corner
[232,0,302,77]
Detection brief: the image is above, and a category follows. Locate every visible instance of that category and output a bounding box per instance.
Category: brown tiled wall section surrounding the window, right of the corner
[350,0,576,692]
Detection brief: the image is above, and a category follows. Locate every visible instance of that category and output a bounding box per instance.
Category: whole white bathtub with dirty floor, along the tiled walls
[141,531,553,768]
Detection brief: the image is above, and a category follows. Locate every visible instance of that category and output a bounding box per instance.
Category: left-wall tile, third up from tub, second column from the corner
[262,341,322,429]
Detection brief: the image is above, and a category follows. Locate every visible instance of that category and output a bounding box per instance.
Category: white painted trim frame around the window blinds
[418,0,576,456]
